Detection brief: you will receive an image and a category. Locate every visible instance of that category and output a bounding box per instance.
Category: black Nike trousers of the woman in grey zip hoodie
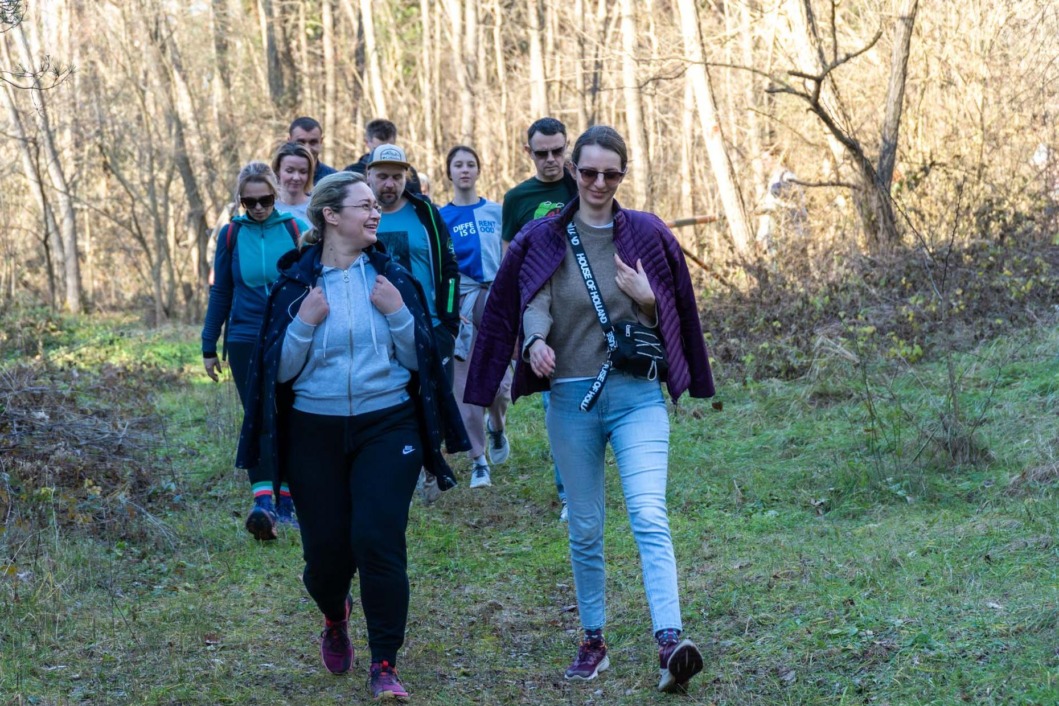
[284,401,424,665]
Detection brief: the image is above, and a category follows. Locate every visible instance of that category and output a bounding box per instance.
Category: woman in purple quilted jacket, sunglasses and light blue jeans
[464,126,714,691]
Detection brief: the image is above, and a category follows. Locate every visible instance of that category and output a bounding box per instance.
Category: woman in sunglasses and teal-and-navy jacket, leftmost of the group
[202,162,309,540]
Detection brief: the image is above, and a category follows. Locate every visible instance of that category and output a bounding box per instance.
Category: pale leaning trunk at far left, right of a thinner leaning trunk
[11,24,82,312]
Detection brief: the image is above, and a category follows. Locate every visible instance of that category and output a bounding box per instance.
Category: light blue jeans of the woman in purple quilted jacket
[545,370,682,632]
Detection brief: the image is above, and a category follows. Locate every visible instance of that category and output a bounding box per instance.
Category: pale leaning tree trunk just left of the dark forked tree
[678,0,751,257]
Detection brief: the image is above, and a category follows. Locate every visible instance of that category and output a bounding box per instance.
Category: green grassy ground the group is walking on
[0,315,1059,706]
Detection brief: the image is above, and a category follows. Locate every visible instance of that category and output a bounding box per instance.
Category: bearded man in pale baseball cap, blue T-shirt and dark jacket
[366,144,460,384]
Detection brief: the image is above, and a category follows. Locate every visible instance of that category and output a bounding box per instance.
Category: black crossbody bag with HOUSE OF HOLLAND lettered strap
[567,221,669,412]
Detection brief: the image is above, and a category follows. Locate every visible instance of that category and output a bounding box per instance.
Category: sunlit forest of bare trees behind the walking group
[0,0,1059,323]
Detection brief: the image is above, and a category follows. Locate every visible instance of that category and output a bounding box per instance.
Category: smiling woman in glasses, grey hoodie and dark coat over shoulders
[237,173,469,701]
